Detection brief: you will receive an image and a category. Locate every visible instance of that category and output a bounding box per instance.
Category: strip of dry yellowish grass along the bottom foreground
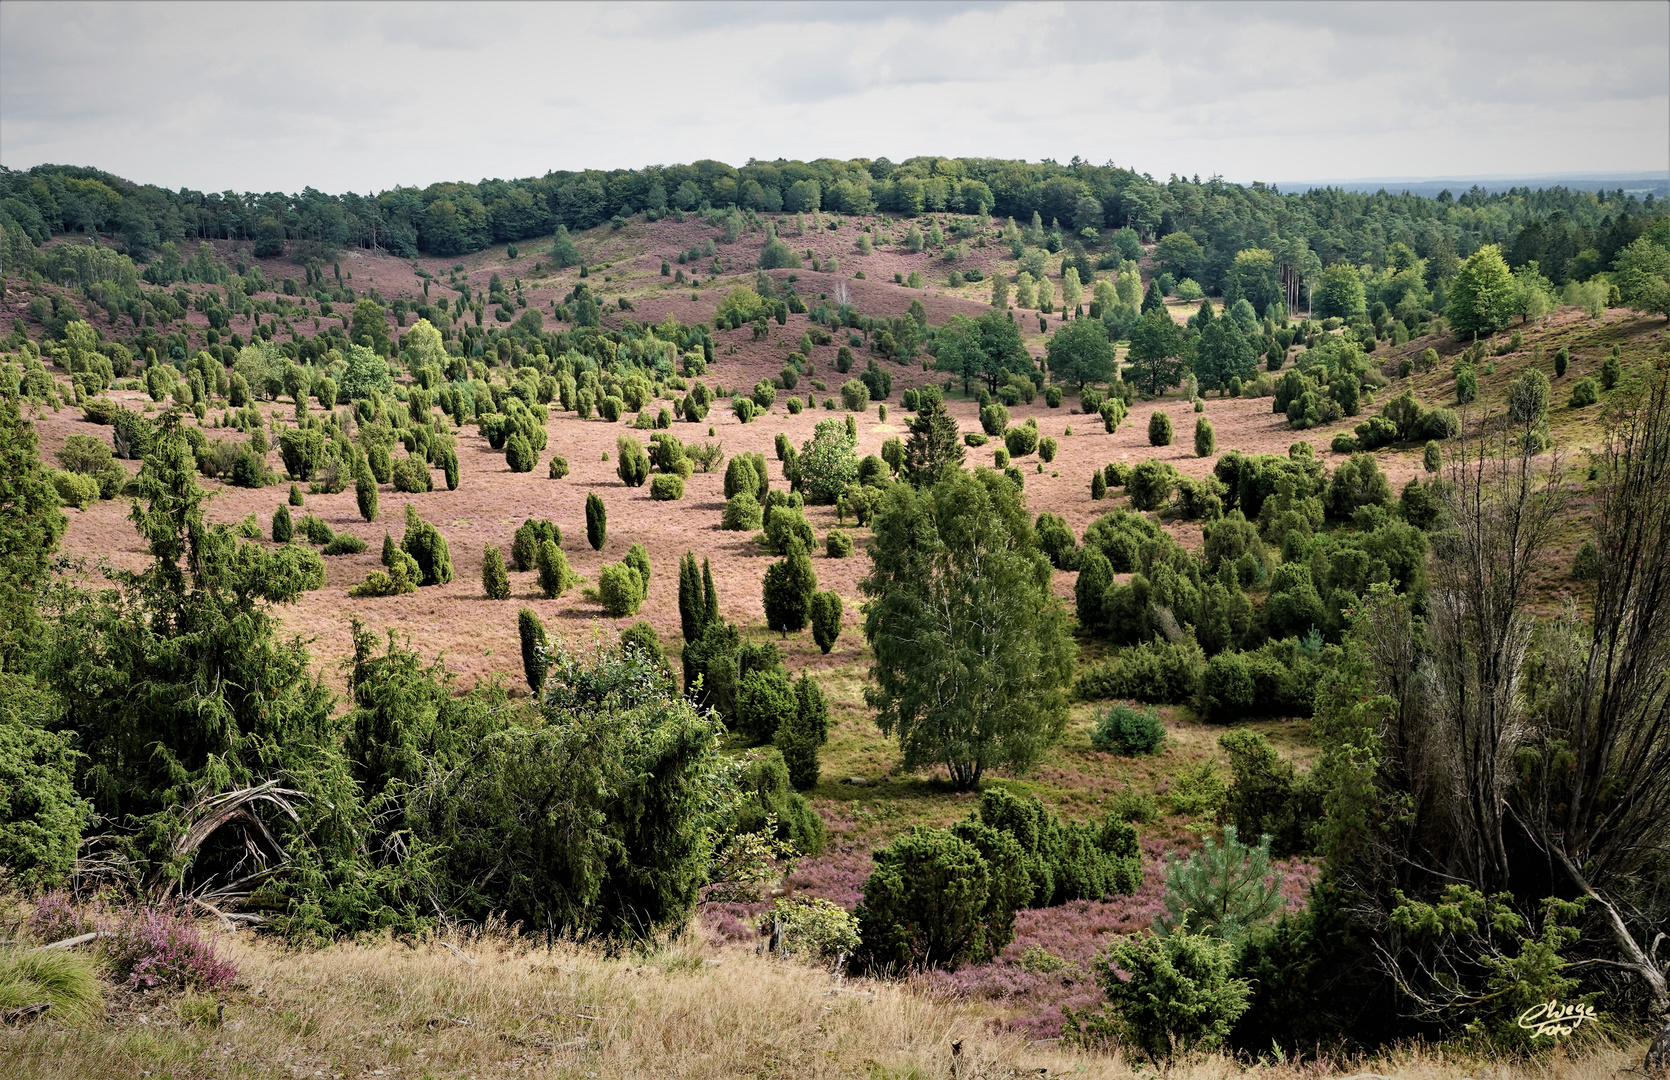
[0,933,1642,1080]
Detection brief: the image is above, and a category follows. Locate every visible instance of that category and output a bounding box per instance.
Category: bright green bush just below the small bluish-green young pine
[1067,933,1251,1065]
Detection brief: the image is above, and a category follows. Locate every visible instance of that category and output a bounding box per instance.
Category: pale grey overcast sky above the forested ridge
[0,0,1670,192]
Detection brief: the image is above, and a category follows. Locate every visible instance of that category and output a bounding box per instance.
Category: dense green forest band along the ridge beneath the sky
[0,157,1658,295]
